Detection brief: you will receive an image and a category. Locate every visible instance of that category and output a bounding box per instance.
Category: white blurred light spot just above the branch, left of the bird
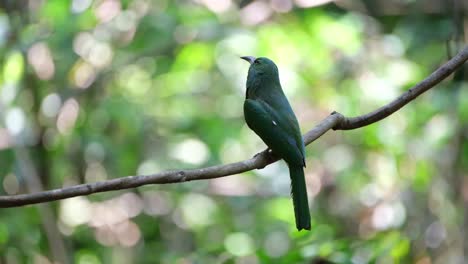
[170,138,210,165]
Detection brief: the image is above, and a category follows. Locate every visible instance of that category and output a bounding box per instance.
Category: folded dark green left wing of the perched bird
[244,99,305,166]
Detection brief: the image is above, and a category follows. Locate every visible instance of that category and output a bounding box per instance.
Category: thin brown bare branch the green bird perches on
[0,47,468,208]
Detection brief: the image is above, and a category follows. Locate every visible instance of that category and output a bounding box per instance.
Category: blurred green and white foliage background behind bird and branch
[0,0,468,264]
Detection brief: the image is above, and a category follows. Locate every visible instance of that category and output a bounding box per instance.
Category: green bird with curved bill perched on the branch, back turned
[241,56,310,231]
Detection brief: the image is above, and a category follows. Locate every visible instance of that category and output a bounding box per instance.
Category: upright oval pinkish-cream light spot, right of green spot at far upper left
[28,42,55,80]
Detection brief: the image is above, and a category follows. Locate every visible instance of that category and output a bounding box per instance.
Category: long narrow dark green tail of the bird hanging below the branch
[289,165,310,231]
